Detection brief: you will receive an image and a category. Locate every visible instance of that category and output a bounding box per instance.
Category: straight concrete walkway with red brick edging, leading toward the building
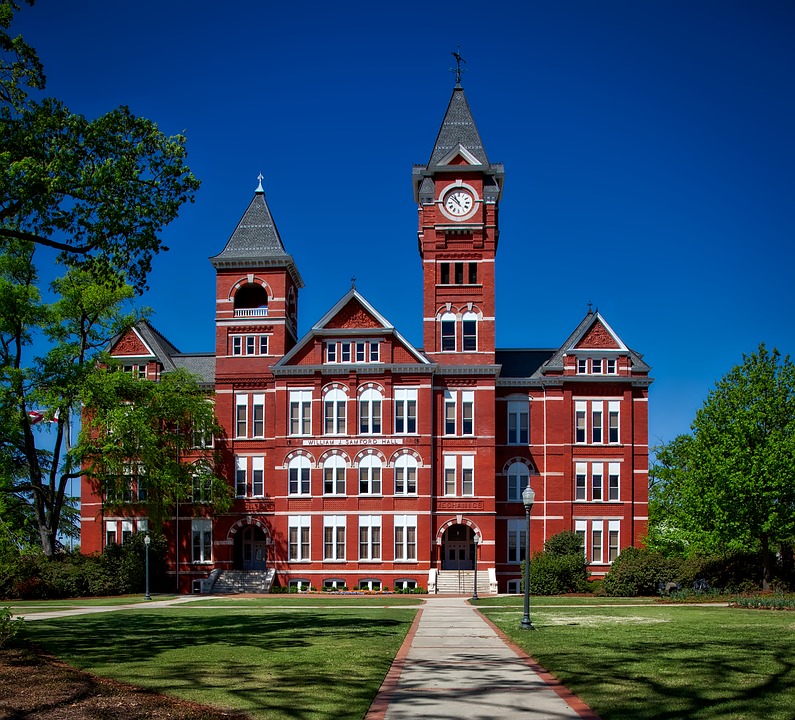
[365,596,599,720]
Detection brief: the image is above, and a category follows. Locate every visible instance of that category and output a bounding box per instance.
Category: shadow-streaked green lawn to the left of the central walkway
[21,604,415,720]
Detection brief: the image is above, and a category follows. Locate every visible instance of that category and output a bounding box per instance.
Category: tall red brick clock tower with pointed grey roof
[412,82,504,365]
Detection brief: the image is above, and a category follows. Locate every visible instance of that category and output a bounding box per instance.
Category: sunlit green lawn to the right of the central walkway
[479,598,795,720]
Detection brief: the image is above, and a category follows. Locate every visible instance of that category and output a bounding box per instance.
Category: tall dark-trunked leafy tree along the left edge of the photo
[0,0,199,555]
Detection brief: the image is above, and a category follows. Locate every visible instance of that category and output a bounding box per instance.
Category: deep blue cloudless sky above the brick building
[10,0,795,444]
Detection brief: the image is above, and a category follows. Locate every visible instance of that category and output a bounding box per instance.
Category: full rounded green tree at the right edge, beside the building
[655,344,795,587]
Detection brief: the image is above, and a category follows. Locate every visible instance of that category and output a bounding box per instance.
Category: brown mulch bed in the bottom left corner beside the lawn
[0,648,248,720]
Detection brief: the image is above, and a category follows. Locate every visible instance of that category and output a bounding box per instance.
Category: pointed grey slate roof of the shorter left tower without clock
[210,185,304,288]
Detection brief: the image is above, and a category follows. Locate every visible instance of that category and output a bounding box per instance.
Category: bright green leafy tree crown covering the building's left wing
[77,366,231,531]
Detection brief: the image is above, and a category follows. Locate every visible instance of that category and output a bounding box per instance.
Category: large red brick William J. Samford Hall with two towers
[82,86,652,592]
